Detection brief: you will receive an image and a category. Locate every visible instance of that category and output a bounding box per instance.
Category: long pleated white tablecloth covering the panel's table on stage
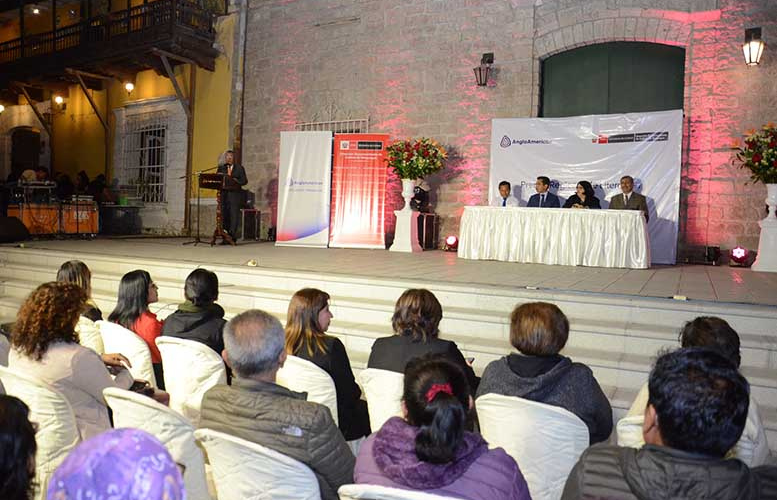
[458,207,650,269]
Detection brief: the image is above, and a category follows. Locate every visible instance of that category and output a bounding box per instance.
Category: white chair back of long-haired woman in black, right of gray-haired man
[276,355,340,425]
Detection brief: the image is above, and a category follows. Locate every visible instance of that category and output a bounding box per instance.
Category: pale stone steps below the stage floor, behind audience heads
[0,247,777,449]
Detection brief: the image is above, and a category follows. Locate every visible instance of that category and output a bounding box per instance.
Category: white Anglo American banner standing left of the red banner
[275,132,332,248]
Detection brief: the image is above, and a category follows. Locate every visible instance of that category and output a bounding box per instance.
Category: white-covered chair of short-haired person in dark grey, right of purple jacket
[475,394,589,500]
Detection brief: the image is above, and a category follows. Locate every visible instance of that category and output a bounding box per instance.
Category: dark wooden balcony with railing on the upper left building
[0,0,218,88]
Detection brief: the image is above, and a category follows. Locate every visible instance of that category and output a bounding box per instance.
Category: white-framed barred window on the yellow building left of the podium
[119,111,168,203]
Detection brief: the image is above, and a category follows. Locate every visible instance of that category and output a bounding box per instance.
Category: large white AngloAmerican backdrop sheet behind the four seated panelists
[488,110,683,264]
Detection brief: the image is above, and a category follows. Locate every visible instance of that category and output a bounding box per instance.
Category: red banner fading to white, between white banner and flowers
[329,134,389,248]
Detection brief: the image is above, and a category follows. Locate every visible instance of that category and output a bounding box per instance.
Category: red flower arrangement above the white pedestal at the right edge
[731,122,777,184]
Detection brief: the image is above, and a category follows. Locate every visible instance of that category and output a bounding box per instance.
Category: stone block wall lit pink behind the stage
[243,0,777,257]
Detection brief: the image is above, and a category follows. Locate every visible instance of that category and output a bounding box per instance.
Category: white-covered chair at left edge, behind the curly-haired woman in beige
[0,367,80,500]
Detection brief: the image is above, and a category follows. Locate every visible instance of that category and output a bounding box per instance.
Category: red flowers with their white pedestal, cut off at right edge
[732,122,777,272]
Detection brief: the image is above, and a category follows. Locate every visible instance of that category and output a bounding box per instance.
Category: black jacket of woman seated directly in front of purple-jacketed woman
[367,335,479,394]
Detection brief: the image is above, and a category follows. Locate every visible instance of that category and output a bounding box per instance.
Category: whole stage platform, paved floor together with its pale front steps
[0,238,777,450]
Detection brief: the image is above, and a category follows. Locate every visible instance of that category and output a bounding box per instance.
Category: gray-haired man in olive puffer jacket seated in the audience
[200,309,355,500]
